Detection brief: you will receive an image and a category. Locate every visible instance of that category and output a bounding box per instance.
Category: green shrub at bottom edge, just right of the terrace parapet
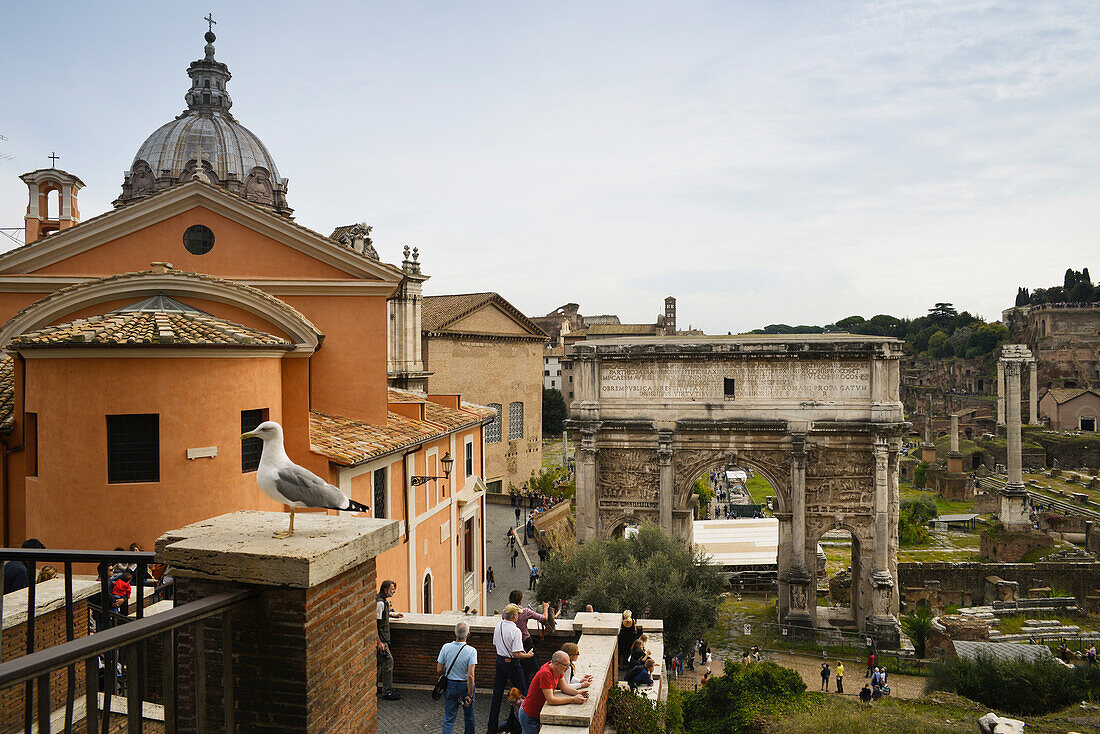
[684,659,806,734]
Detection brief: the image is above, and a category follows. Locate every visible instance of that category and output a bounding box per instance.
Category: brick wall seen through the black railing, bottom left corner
[0,592,88,732]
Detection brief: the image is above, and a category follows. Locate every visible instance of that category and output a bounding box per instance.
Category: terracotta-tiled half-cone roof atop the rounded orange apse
[11,311,294,349]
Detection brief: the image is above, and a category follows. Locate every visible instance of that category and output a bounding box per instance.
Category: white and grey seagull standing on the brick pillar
[241,420,371,538]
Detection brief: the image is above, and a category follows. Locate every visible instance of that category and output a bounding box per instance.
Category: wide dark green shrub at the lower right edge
[928,654,1100,714]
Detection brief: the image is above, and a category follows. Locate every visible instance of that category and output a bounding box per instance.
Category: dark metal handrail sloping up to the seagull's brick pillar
[0,589,260,690]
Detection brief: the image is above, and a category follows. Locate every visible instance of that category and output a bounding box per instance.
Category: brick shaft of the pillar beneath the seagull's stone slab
[176,559,377,734]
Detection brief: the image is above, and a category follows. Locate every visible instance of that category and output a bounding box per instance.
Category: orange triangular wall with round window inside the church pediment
[32,207,355,281]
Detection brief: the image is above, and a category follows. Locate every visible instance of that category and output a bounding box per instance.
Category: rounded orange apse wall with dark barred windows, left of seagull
[25,355,282,549]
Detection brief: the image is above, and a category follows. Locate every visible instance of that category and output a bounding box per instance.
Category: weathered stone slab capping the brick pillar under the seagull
[156,511,399,589]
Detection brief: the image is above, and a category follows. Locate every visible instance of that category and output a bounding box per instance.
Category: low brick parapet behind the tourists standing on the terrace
[391,622,578,692]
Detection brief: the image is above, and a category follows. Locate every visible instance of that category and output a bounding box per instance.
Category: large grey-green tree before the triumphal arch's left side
[537,524,728,650]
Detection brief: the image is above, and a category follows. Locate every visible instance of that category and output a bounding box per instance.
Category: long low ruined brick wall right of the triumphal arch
[898,561,1100,603]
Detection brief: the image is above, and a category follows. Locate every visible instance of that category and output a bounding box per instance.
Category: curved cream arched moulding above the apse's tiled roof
[0,270,325,353]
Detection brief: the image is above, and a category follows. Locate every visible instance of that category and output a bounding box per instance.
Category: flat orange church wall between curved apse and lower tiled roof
[281,296,389,424]
